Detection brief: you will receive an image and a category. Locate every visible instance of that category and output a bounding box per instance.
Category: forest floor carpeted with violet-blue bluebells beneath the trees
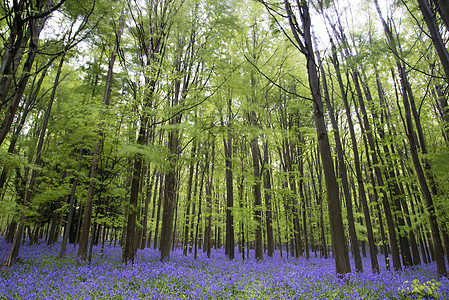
[0,237,449,299]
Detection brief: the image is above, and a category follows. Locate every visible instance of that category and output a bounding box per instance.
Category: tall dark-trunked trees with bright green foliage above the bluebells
[0,0,449,275]
